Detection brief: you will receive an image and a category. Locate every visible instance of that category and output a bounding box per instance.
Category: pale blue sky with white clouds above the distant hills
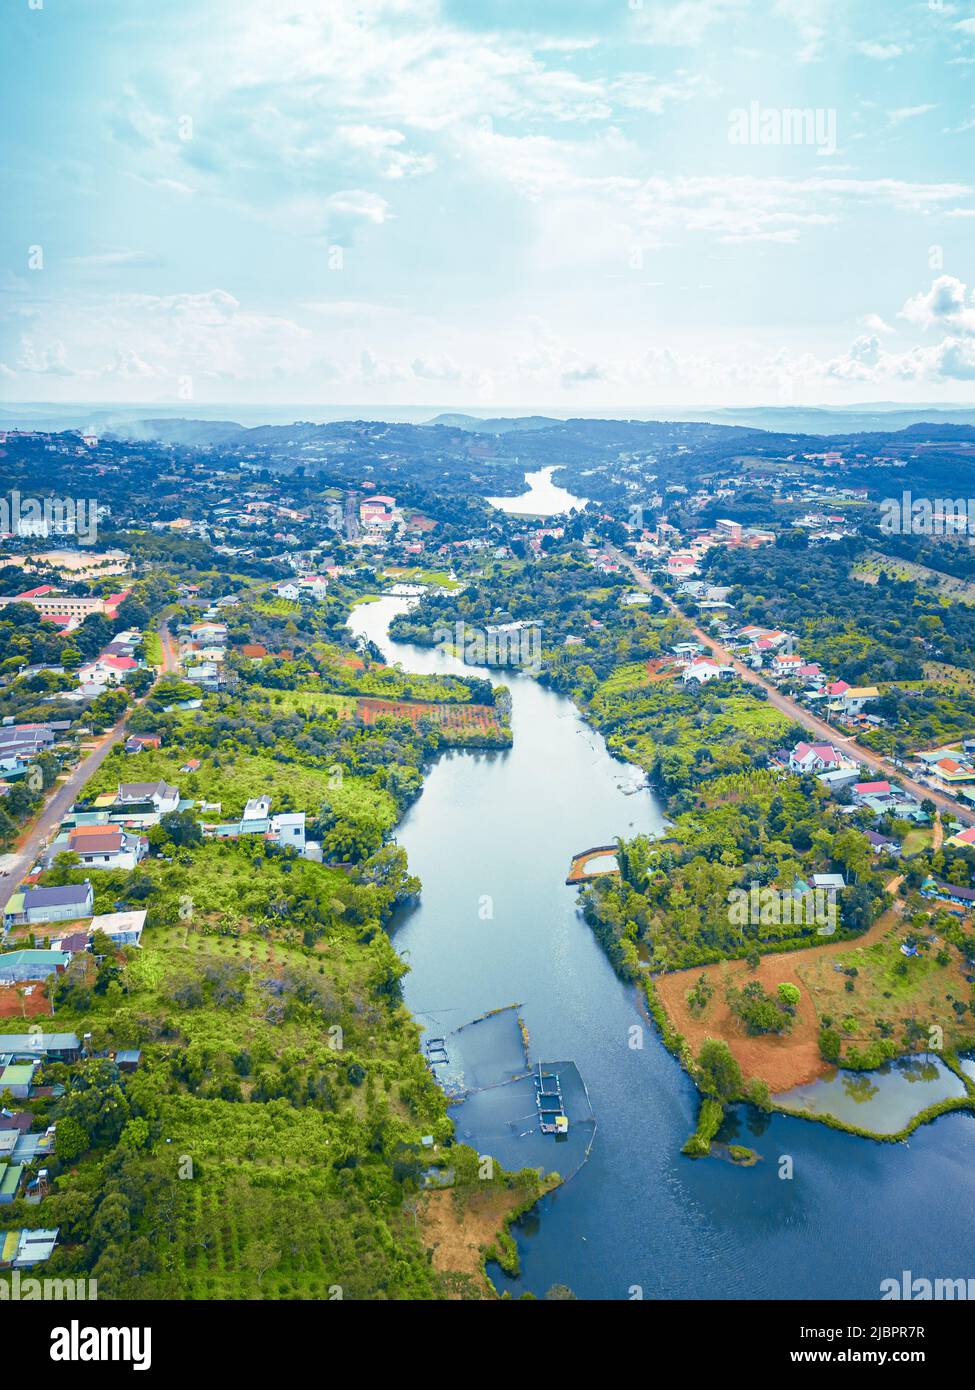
[0,0,975,414]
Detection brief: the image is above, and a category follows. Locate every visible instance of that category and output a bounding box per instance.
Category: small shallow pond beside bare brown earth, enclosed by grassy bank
[775,1054,965,1134]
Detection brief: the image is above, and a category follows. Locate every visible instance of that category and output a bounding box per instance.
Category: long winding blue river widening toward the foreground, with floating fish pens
[350,598,975,1298]
